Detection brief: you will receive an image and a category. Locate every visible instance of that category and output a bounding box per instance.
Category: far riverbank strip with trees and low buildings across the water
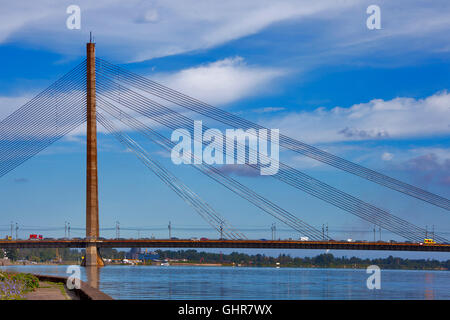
[4,248,450,270]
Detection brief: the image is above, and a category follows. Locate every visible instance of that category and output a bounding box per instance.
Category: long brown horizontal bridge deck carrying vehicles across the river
[0,239,450,252]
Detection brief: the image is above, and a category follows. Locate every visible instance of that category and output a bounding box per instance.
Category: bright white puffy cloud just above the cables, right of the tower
[152,57,286,105]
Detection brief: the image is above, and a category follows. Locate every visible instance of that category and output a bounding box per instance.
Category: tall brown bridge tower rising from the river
[82,40,104,266]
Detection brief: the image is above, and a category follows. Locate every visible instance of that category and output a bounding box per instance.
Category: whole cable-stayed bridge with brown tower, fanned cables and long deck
[0,42,450,265]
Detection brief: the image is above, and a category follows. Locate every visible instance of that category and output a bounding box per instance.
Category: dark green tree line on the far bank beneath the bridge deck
[0,248,450,270]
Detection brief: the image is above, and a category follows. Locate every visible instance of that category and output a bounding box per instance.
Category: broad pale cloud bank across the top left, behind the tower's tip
[0,0,357,61]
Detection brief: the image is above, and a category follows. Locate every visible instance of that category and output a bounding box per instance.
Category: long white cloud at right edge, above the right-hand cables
[266,91,450,143]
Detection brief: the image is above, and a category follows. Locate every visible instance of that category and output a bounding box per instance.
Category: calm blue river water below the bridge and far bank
[0,265,450,300]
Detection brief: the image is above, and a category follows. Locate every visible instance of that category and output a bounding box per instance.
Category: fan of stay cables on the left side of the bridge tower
[0,61,85,177]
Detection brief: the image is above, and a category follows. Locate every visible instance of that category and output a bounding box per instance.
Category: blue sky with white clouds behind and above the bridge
[0,0,450,260]
